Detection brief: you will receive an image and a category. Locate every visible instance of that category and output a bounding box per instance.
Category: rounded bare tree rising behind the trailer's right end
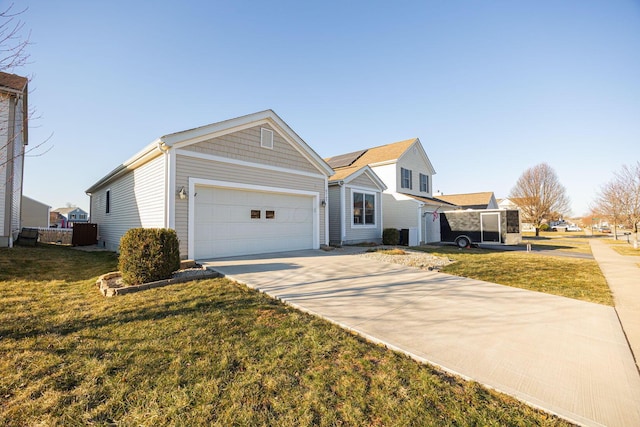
[509,163,569,236]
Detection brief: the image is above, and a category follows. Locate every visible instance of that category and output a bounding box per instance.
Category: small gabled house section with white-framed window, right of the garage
[328,164,387,246]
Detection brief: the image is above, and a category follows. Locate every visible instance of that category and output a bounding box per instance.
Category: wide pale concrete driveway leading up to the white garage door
[201,250,640,426]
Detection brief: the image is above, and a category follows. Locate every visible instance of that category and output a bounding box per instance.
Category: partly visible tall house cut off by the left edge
[0,72,29,247]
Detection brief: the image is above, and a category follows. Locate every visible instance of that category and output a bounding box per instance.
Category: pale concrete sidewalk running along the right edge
[589,238,640,372]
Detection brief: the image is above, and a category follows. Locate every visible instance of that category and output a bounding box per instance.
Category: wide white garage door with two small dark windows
[194,186,314,259]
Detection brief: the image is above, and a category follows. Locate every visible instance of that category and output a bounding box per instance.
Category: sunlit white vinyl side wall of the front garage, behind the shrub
[91,156,165,251]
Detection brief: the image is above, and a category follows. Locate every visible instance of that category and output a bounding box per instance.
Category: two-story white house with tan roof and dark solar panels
[327,138,455,245]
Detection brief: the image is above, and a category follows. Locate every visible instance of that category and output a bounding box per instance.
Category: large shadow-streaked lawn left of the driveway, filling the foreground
[0,246,568,426]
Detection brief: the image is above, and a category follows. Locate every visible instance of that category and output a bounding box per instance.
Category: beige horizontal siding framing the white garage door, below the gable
[175,155,328,260]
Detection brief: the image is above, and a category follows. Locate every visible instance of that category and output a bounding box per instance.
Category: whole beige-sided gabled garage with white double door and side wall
[87,110,333,259]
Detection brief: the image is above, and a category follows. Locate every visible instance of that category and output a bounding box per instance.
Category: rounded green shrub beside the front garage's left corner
[118,228,180,285]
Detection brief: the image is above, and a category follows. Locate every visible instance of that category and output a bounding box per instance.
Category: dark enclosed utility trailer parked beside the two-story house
[440,209,522,248]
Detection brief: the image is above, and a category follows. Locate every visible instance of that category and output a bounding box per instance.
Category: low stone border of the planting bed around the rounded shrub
[96,260,221,297]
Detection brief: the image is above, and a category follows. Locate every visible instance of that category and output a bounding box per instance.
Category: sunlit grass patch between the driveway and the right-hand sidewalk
[414,243,613,306]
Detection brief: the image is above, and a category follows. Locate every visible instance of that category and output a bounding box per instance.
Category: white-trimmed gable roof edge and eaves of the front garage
[85,110,333,194]
